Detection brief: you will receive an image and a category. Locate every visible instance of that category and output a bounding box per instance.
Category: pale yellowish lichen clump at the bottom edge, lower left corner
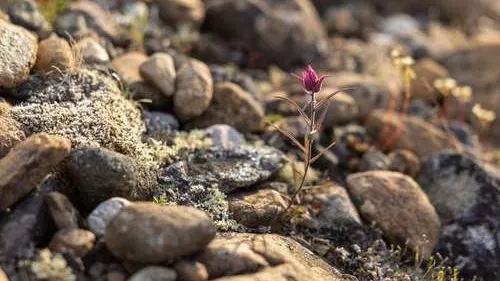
[30,249,76,281]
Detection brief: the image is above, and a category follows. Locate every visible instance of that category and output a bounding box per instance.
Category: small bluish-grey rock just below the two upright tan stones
[143,111,179,139]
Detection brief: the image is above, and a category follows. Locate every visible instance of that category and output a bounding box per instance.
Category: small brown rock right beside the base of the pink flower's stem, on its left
[228,189,289,227]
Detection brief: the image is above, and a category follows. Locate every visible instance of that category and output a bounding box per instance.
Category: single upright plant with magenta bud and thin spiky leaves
[270,65,342,214]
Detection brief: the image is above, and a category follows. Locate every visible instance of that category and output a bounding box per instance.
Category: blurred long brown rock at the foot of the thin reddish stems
[366,111,454,157]
